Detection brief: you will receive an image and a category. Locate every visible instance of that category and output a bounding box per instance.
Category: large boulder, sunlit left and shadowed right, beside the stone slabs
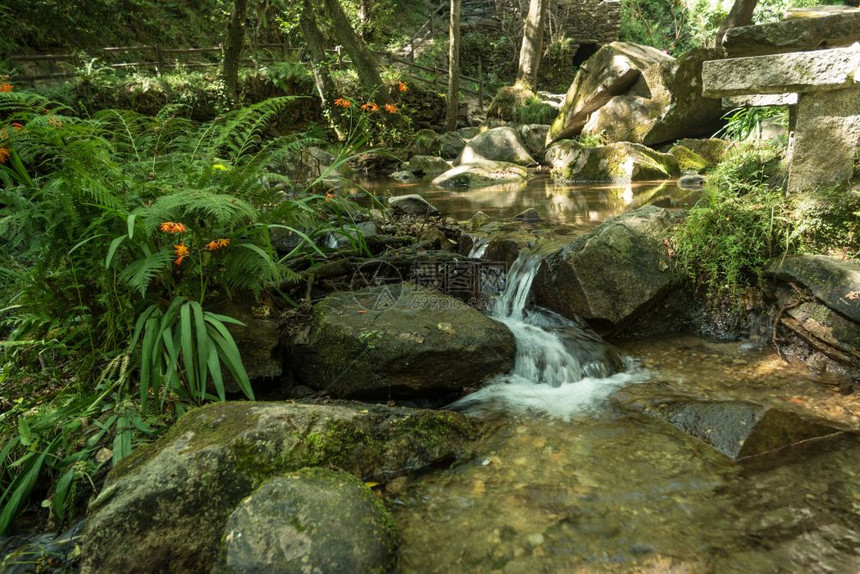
[582,48,723,145]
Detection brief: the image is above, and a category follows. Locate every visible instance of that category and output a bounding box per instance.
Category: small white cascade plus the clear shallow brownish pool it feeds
[394,251,860,574]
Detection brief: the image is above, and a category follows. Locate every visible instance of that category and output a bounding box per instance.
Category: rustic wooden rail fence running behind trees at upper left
[5,44,484,108]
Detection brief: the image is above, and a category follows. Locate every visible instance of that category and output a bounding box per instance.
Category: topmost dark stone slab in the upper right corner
[723,10,860,58]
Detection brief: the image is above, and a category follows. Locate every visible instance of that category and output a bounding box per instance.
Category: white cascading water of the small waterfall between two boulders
[452,251,645,419]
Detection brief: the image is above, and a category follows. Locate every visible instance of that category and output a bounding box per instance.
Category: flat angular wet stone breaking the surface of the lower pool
[611,383,844,461]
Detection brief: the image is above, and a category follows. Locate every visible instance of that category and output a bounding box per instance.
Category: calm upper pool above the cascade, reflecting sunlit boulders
[351,176,699,226]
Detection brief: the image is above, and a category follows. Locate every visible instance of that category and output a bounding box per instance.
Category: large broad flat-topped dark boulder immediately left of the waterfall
[292,284,515,398]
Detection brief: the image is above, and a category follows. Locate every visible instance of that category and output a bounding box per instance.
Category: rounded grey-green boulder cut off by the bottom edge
[212,468,396,574]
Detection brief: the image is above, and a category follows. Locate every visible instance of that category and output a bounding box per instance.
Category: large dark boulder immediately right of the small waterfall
[532,206,683,335]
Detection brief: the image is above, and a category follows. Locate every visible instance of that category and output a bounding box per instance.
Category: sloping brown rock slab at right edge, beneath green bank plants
[765,255,860,323]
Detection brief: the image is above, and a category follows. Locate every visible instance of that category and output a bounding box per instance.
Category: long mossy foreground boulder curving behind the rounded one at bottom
[81,402,476,574]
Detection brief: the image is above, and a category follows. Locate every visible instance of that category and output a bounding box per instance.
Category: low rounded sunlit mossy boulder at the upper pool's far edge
[546,140,680,183]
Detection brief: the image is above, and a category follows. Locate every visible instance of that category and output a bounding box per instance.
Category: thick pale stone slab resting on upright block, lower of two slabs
[702,44,860,98]
